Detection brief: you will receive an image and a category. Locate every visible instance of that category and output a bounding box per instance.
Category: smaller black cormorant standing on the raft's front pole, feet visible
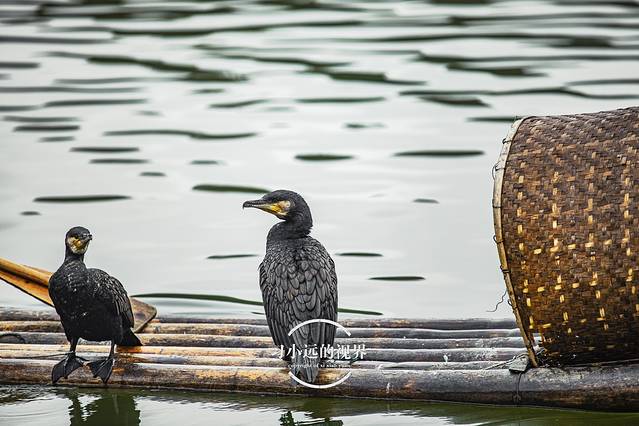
[49,226,142,383]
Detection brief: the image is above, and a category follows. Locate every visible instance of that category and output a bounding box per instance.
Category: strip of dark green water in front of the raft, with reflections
[0,386,639,426]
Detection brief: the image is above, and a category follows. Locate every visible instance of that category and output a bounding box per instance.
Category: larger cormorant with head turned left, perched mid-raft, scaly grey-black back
[242,190,337,383]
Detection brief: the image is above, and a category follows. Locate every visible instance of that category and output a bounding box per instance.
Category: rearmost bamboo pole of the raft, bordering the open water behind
[0,308,517,330]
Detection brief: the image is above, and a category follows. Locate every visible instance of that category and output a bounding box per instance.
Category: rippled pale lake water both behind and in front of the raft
[0,0,639,425]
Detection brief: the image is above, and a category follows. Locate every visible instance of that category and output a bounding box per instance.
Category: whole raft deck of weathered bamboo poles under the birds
[0,309,639,410]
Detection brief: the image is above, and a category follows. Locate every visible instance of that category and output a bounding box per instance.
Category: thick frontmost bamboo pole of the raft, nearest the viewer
[0,359,639,411]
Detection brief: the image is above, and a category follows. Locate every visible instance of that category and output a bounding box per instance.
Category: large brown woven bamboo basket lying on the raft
[493,107,639,366]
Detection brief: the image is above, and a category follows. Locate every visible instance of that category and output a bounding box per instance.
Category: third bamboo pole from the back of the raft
[0,331,524,349]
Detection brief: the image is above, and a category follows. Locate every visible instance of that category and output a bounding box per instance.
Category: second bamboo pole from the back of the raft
[0,320,520,339]
